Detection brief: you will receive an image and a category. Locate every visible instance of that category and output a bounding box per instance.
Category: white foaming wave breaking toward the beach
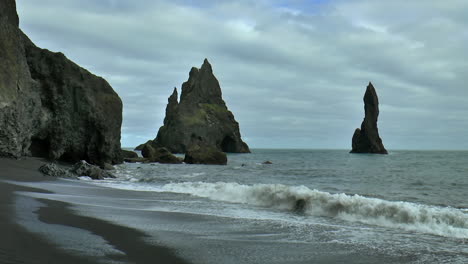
[160,182,468,239]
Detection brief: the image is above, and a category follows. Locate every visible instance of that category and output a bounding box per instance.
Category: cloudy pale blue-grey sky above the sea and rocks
[17,0,468,150]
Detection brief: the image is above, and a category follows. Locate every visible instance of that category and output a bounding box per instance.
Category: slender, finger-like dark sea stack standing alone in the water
[351,82,388,154]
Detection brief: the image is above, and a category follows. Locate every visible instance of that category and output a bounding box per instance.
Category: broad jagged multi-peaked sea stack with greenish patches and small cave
[144,59,250,153]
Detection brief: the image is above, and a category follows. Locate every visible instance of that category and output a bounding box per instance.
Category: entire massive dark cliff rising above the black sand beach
[0,0,122,166]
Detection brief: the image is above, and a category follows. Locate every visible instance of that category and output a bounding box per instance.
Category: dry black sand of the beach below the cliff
[0,158,188,264]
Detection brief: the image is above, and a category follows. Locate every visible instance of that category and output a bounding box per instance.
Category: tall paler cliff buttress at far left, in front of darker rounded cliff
[0,0,40,157]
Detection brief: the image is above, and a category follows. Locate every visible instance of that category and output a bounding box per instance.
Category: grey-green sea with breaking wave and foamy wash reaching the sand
[11,149,468,264]
